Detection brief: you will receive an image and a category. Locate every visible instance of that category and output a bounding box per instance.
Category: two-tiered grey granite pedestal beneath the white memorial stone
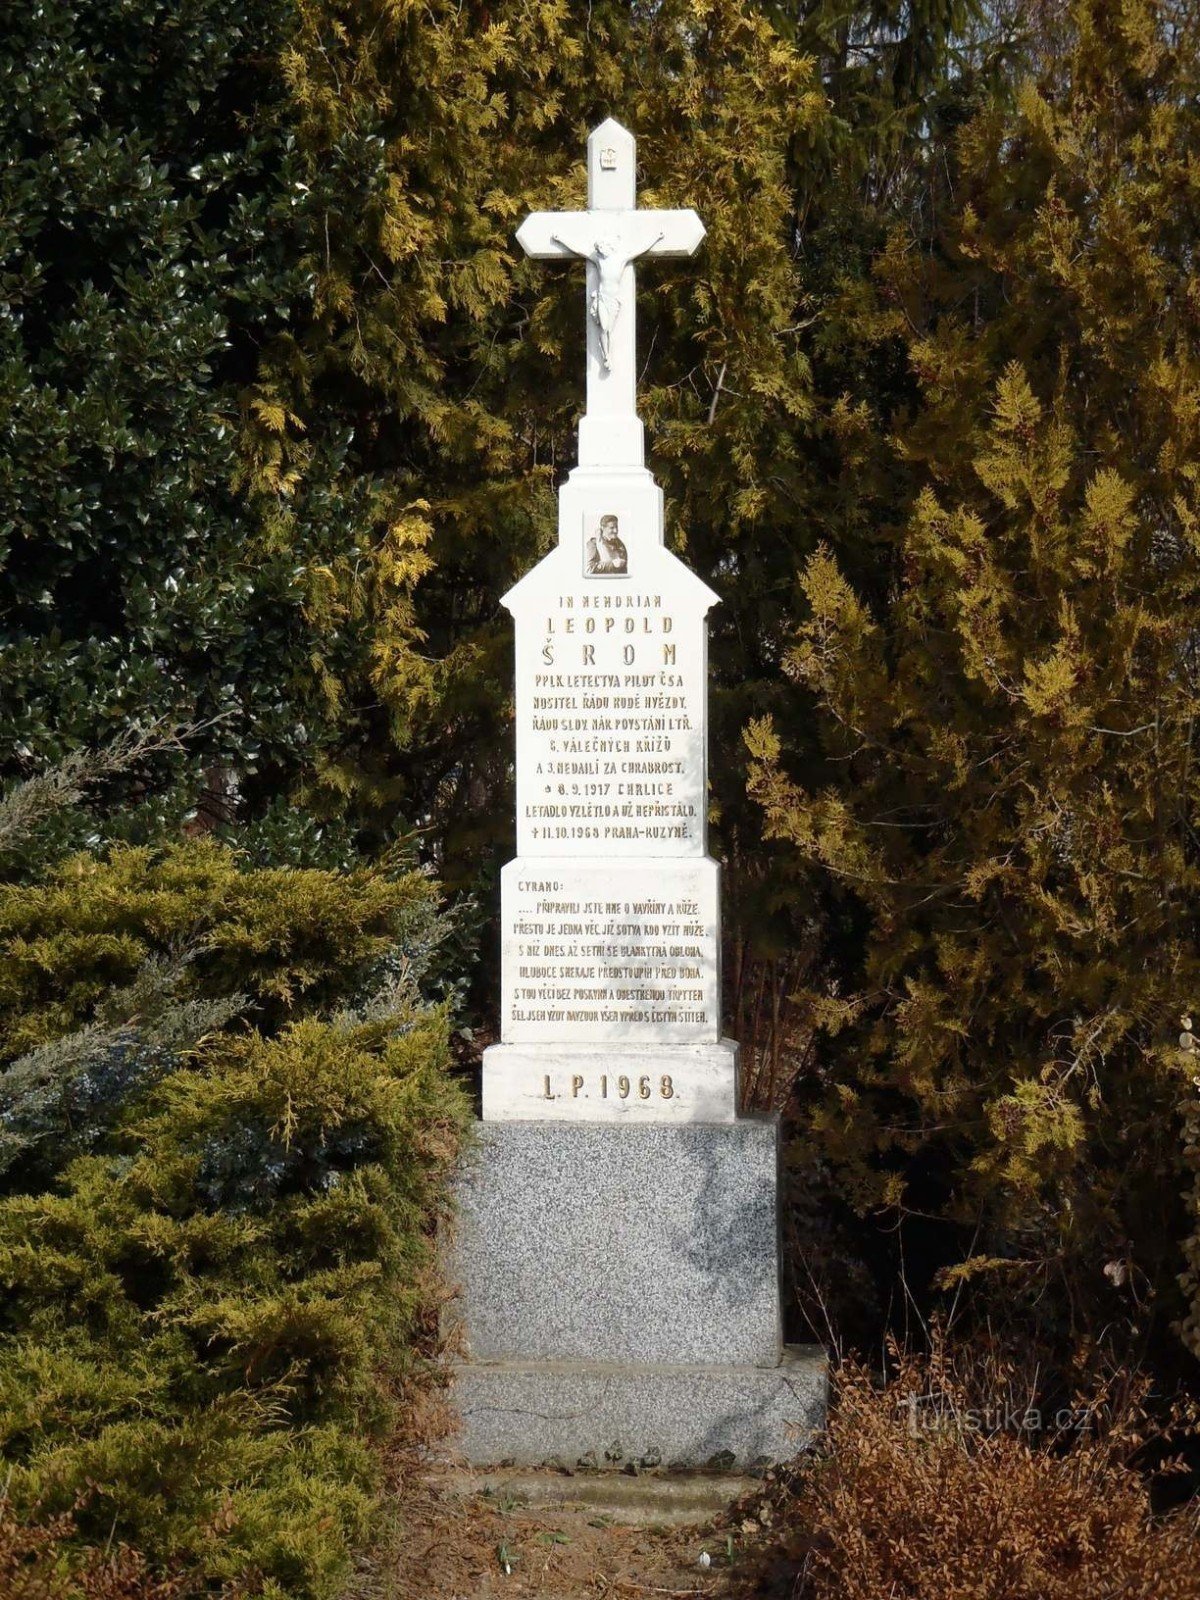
[450,1118,826,1467]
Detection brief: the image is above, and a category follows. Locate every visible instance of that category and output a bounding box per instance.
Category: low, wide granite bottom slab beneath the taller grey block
[453,1346,826,1467]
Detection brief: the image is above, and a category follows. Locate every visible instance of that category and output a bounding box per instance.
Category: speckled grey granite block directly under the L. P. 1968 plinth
[446,1118,782,1368]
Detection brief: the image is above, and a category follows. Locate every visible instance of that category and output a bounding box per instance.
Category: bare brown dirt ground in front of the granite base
[374,1464,803,1600]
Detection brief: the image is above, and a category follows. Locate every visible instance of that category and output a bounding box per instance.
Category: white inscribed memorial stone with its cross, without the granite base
[483,120,738,1122]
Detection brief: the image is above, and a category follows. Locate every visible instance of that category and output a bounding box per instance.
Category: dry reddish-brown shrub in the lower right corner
[776,1347,1200,1600]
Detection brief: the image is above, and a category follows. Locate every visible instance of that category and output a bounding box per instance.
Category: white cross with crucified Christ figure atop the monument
[517,117,704,467]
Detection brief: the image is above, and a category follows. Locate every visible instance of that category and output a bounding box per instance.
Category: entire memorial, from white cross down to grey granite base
[451,120,824,1466]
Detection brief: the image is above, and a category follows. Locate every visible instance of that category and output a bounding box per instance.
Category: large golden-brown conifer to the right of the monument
[749,0,1200,1349]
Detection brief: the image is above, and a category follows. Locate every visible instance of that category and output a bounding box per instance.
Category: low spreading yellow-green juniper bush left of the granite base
[0,843,464,1597]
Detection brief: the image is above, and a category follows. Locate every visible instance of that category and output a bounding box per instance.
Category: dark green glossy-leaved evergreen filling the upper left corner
[0,0,438,864]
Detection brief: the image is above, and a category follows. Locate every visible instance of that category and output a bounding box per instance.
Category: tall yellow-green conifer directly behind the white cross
[245,0,824,872]
